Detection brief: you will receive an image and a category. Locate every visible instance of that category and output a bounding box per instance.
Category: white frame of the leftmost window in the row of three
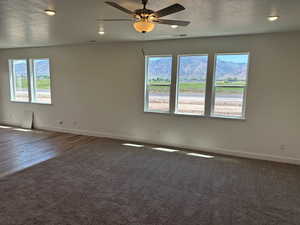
[144,55,174,114]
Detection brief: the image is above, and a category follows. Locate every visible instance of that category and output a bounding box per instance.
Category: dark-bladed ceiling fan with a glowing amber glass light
[98,0,190,33]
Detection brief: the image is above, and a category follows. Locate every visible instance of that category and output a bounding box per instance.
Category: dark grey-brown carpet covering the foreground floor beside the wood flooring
[0,139,300,225]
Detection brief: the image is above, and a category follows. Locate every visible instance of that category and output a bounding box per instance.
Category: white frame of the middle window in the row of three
[176,53,209,117]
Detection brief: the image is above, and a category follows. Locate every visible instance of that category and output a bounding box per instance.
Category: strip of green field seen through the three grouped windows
[149,81,246,94]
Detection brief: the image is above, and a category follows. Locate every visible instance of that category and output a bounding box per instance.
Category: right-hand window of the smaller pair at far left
[31,59,51,104]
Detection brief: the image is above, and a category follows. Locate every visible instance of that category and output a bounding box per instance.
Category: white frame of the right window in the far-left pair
[29,58,52,105]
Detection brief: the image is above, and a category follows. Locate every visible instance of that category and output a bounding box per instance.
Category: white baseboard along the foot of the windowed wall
[1,123,300,165]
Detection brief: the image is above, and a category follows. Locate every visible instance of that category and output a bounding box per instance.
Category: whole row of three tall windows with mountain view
[144,53,249,119]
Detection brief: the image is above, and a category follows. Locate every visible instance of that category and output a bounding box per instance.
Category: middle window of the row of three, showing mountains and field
[176,55,208,115]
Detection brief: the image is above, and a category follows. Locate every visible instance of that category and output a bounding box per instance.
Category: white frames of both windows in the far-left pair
[8,57,53,105]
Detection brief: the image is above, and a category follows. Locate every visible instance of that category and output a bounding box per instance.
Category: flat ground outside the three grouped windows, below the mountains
[149,81,246,117]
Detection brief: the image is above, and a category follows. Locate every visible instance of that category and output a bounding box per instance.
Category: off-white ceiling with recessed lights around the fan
[0,0,300,48]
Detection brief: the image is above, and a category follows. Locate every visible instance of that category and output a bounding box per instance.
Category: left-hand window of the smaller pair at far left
[9,59,29,102]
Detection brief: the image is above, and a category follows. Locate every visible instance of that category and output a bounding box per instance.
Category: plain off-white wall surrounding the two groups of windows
[0,32,300,163]
